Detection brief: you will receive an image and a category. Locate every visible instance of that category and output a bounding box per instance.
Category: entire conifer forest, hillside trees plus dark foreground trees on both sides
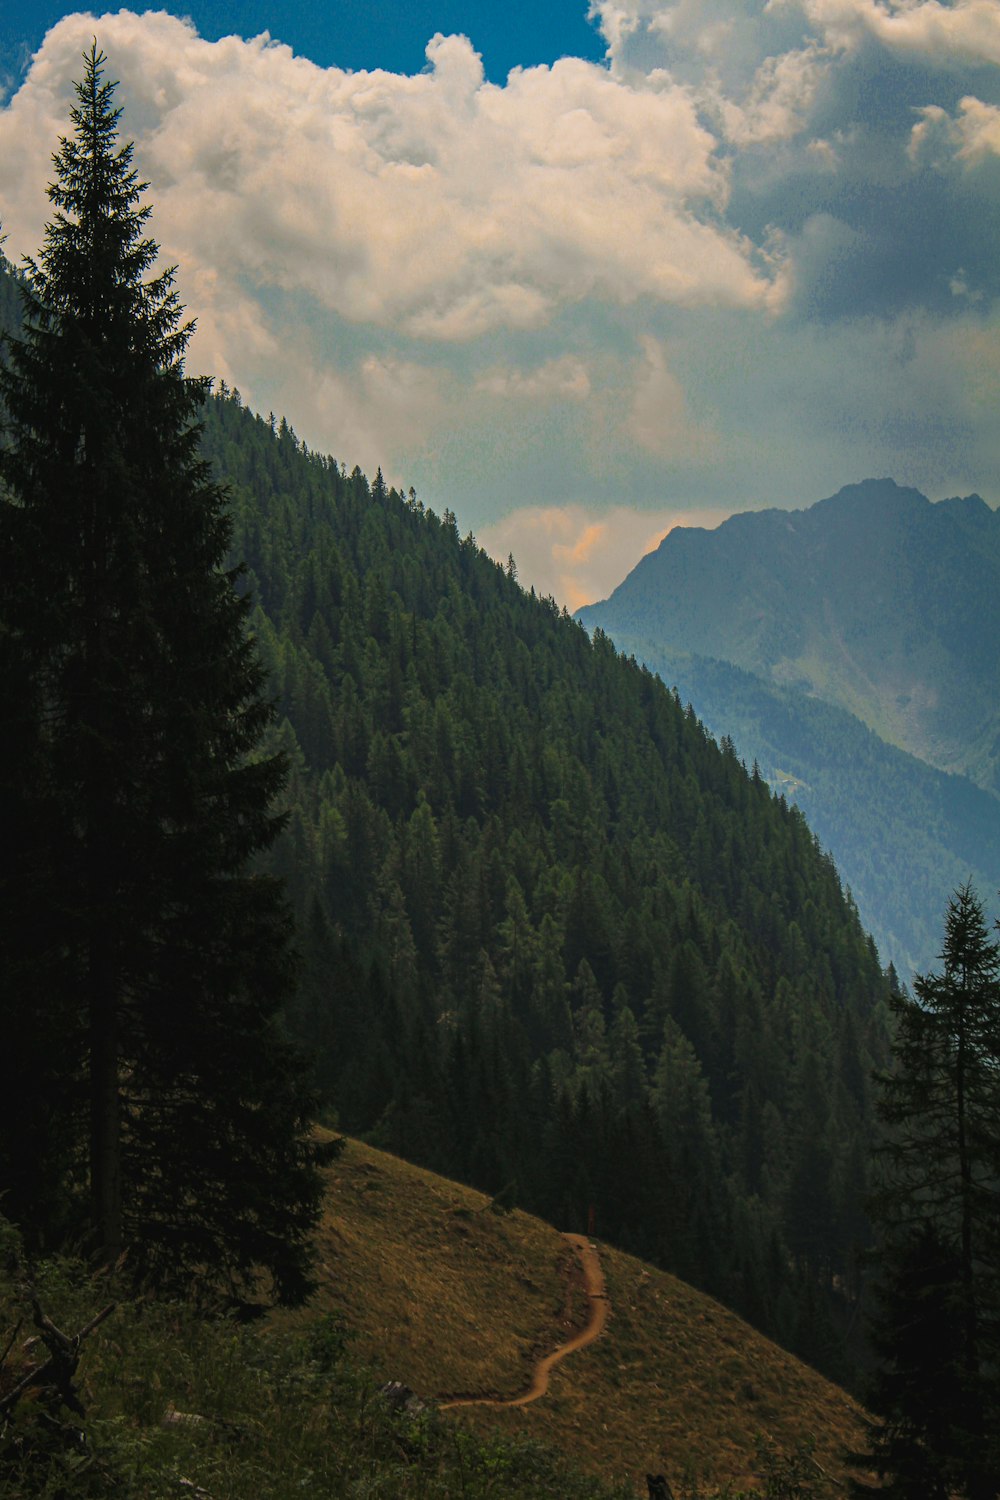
[0,42,1000,1500]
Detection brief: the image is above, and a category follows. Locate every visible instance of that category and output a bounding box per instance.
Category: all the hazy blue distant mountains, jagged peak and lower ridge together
[577,480,1000,977]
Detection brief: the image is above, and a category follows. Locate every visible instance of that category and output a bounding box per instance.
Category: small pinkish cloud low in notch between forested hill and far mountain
[478,504,730,611]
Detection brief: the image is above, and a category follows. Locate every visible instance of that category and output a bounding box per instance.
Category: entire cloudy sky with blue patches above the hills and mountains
[0,0,1000,609]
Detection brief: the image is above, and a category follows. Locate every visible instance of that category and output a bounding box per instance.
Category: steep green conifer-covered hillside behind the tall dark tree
[194,392,885,1368]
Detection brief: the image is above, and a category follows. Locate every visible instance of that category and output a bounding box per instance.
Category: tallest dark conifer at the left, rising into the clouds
[0,44,318,1298]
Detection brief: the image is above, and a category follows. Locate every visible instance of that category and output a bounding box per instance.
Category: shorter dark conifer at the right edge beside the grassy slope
[870,887,1000,1500]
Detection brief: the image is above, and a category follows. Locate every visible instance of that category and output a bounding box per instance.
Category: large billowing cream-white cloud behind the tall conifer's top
[0,11,775,351]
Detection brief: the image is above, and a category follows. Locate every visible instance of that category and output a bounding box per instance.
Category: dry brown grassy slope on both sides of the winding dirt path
[290,1142,862,1491]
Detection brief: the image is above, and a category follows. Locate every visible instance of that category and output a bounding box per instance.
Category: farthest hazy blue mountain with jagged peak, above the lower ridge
[579,480,1000,791]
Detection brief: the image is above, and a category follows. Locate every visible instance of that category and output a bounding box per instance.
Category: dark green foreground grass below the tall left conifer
[0,1236,625,1500]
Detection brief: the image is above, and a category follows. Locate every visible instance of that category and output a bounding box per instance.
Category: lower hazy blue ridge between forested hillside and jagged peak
[605,635,1000,983]
